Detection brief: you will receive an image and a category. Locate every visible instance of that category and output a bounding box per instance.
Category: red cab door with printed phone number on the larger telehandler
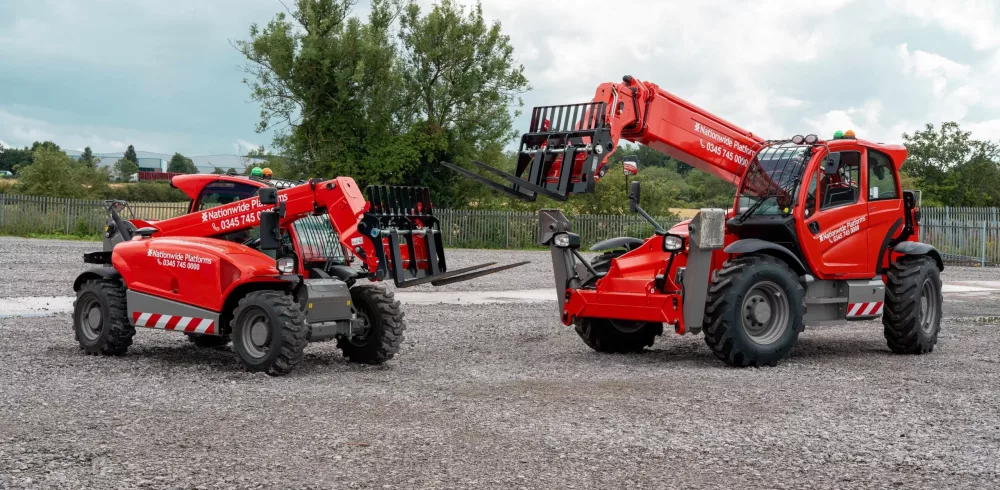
[799,148,871,279]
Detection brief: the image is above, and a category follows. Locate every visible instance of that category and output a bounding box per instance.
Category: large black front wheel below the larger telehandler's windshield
[702,255,806,367]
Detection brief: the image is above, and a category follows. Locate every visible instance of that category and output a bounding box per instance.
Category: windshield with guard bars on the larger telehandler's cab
[739,144,812,215]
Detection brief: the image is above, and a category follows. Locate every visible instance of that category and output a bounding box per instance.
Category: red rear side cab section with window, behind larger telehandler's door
[866,148,905,277]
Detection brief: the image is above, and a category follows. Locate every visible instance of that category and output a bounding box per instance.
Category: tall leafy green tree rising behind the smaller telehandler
[236,0,528,205]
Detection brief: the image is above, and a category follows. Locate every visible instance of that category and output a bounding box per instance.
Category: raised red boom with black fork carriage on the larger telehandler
[444,76,765,201]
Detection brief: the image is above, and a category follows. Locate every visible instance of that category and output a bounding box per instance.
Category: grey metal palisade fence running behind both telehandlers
[0,194,1000,266]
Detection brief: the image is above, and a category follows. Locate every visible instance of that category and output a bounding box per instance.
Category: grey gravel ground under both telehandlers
[0,239,1000,489]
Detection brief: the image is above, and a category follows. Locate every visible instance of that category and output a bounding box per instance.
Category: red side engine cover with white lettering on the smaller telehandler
[111,237,280,311]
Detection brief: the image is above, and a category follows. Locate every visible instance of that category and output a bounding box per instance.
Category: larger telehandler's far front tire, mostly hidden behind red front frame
[573,250,663,354]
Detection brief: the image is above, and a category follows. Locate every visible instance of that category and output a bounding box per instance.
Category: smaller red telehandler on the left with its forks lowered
[73,175,525,375]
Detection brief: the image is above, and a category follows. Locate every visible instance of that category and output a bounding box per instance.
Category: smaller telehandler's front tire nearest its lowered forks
[337,284,406,364]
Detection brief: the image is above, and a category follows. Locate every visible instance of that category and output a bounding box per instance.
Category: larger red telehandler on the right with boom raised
[444,76,944,366]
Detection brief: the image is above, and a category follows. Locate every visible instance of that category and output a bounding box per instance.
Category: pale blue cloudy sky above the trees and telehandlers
[0,0,1000,155]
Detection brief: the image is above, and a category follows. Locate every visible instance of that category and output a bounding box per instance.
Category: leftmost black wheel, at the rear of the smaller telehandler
[73,279,135,356]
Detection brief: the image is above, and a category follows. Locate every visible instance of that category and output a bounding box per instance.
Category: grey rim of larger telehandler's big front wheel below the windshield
[740,281,791,345]
